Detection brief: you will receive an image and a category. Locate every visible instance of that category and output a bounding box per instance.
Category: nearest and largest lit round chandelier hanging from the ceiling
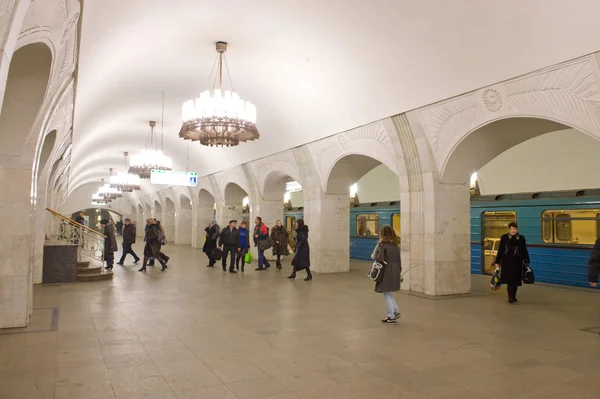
[179,42,260,147]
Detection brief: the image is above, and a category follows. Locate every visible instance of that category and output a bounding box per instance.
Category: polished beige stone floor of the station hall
[0,245,600,399]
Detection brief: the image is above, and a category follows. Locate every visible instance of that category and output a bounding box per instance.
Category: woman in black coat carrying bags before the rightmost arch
[496,222,529,303]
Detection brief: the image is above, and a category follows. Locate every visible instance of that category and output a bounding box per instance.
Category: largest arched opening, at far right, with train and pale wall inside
[436,118,600,286]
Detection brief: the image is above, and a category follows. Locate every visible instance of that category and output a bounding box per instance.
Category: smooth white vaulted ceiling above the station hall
[70,0,600,197]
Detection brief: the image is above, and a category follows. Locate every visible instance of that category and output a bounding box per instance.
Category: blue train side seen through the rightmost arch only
[471,190,600,287]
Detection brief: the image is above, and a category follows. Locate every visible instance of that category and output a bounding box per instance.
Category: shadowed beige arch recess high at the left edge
[0,42,52,156]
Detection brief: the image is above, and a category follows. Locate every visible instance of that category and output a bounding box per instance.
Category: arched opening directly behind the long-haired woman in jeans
[325,154,401,270]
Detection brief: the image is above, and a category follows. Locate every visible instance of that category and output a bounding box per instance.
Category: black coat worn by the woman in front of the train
[496,233,529,286]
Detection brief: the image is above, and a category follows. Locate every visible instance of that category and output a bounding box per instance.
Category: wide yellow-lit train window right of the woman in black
[542,209,600,245]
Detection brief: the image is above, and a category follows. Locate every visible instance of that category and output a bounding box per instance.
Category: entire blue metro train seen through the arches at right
[284,189,600,287]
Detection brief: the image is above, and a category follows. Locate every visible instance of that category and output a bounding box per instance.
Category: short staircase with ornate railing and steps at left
[46,208,113,282]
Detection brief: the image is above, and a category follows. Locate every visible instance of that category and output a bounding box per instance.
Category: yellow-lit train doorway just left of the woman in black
[481,211,517,274]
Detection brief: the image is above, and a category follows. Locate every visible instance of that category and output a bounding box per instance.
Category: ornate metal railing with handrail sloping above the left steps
[46,208,107,263]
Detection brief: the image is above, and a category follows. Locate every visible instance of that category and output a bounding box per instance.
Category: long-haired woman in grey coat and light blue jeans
[371,226,402,324]
